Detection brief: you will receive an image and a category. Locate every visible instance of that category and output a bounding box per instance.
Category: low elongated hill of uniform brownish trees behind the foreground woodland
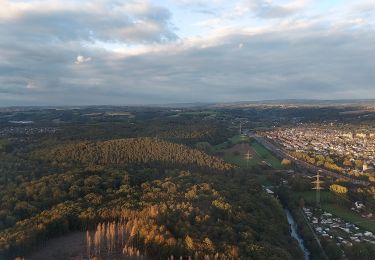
[38,138,233,171]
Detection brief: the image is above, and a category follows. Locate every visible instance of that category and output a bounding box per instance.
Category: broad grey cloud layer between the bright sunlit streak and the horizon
[0,25,375,104]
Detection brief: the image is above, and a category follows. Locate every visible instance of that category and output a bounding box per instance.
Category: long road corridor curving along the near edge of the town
[249,134,370,186]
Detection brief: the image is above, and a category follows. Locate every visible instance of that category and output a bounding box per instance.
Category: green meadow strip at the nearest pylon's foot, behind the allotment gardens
[293,191,375,233]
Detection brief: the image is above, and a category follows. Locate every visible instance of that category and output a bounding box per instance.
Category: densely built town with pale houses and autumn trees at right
[265,124,375,176]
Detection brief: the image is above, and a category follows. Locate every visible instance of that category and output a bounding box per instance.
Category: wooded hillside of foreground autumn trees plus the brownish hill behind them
[0,138,301,259]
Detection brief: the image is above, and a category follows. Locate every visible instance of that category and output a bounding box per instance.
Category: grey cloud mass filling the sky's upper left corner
[0,0,177,44]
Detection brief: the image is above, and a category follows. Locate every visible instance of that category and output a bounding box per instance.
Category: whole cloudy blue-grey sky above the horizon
[0,0,375,106]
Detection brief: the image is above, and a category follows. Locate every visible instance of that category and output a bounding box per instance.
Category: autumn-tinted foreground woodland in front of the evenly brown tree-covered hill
[0,169,300,259]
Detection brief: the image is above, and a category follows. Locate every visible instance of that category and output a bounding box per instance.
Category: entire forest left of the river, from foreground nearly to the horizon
[0,106,302,259]
